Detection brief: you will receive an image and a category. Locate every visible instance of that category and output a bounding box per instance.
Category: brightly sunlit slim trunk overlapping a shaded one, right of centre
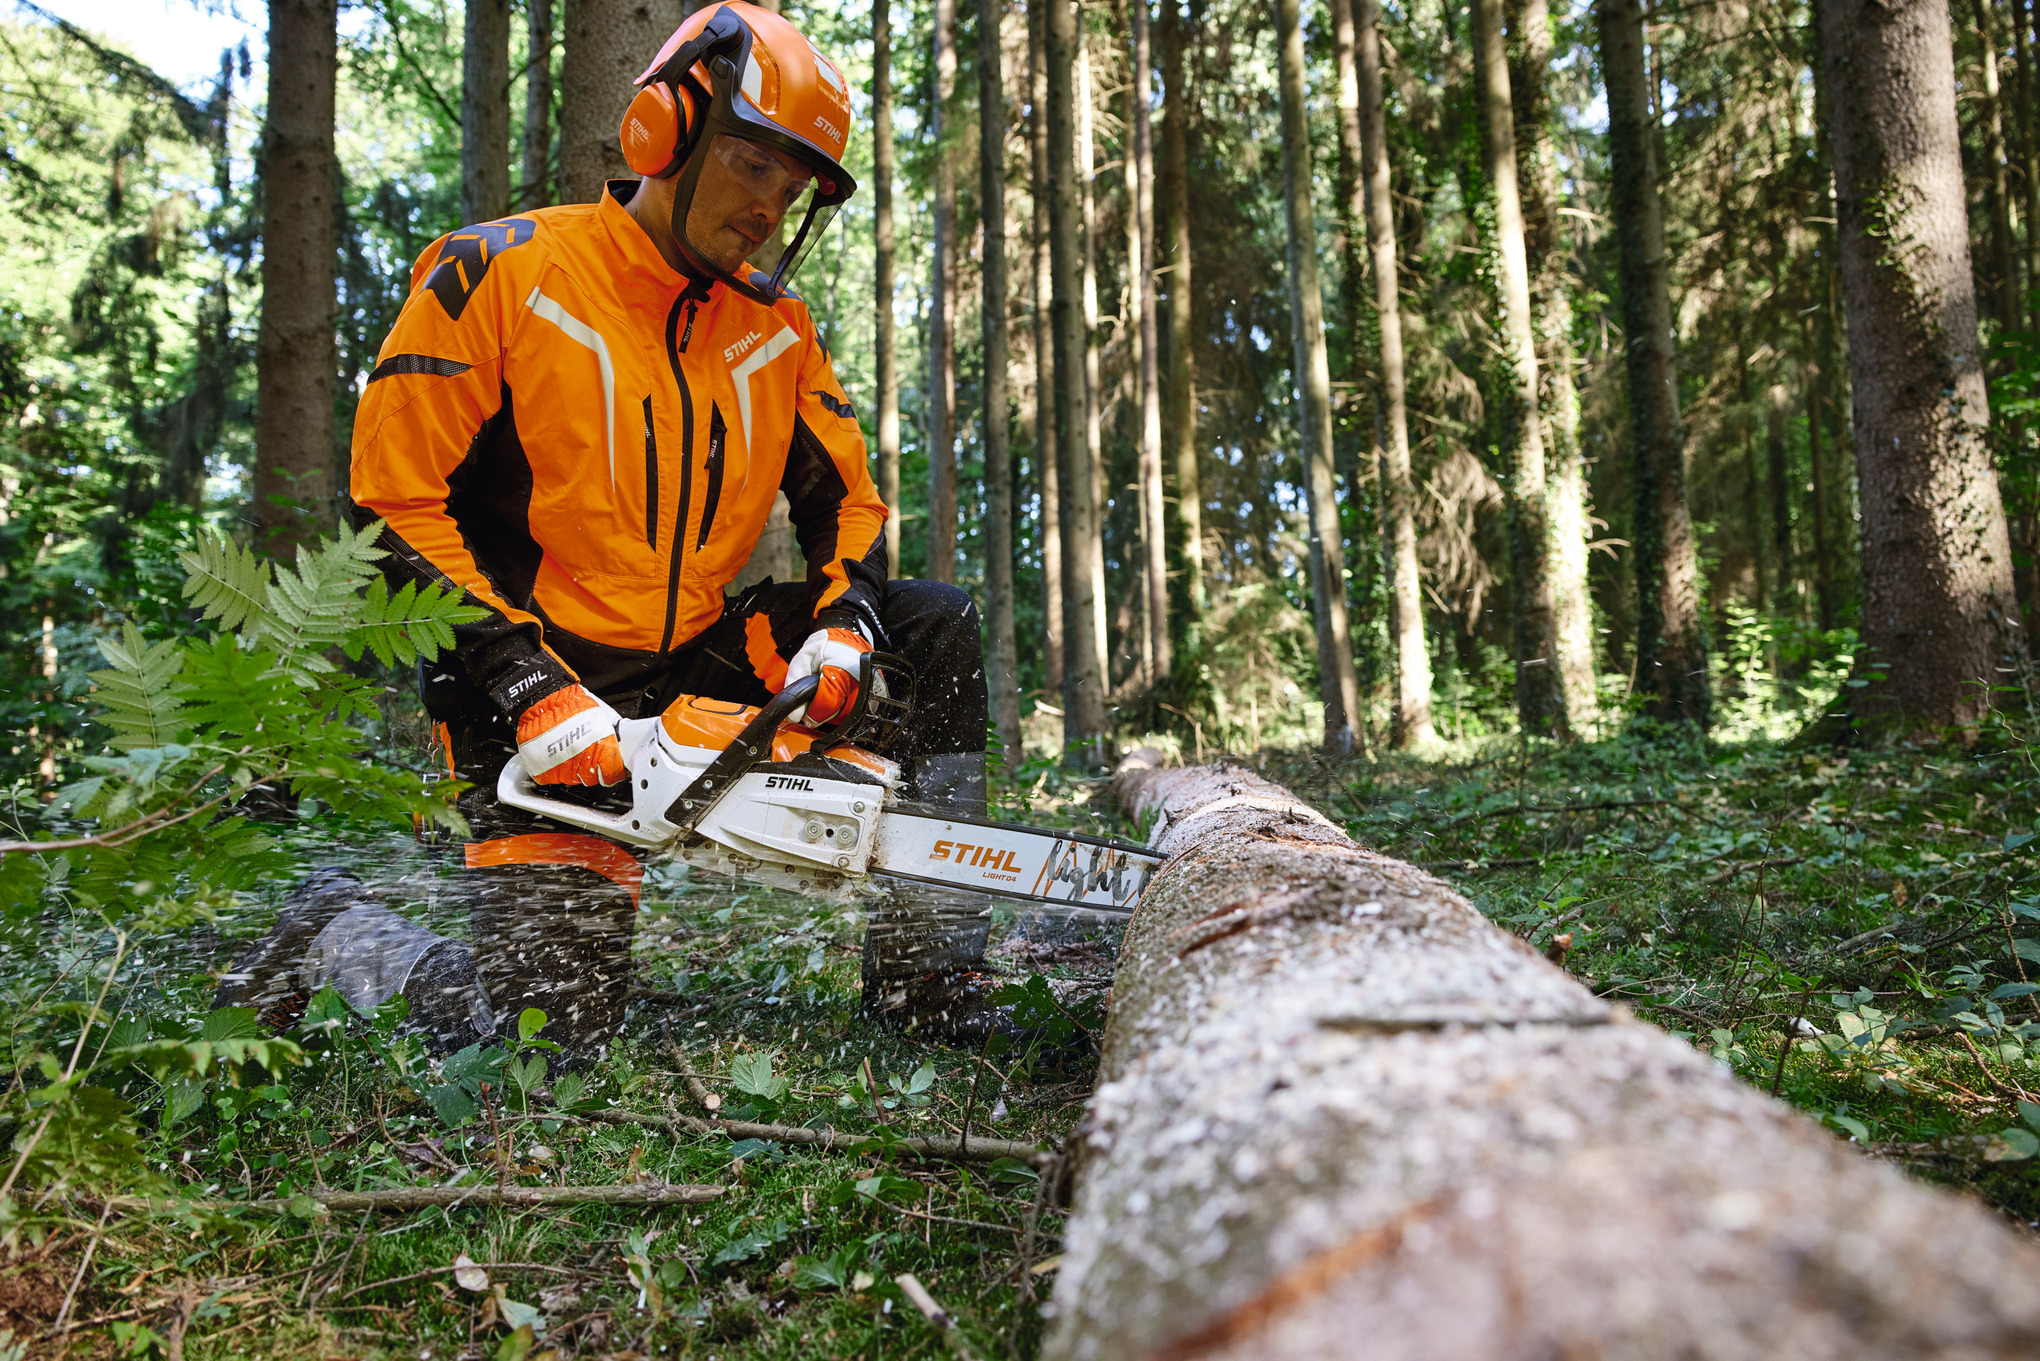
[1473,0,1571,737]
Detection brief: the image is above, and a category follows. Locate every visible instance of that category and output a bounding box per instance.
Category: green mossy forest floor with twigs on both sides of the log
[15,733,2040,1361]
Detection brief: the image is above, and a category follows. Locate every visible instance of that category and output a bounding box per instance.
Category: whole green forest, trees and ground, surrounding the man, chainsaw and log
[0,0,2040,1357]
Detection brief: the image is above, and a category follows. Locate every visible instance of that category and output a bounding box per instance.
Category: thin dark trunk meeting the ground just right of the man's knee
[977,0,1022,767]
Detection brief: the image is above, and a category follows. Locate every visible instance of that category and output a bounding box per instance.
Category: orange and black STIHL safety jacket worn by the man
[351,180,887,716]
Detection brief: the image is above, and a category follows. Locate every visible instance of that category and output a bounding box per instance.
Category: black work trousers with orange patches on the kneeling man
[420,582,985,1051]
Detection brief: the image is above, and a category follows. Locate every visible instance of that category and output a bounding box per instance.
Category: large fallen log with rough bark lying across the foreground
[1044,753,2040,1361]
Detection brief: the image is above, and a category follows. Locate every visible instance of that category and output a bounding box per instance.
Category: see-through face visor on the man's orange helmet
[687,133,836,296]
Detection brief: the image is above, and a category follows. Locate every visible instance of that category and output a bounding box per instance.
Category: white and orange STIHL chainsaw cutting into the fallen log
[496,653,1161,914]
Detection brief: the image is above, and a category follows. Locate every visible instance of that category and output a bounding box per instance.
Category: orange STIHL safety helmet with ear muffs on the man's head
[620,0,857,304]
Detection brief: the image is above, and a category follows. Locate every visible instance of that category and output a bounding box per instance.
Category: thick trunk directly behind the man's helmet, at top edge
[559,0,679,204]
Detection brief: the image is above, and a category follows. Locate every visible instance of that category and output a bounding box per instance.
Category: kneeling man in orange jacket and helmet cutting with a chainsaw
[220,2,998,1055]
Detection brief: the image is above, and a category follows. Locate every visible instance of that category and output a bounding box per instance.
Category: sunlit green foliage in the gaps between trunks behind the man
[0,0,1942,771]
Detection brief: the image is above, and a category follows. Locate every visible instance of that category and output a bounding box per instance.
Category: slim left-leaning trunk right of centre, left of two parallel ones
[1275,0,1361,753]
